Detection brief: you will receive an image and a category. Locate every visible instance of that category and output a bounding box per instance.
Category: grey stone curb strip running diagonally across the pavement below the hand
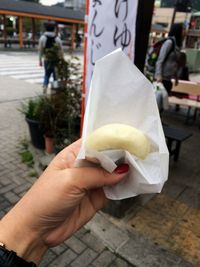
[85,212,194,267]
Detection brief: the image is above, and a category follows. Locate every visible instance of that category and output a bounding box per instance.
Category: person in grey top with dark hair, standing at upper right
[155,23,184,94]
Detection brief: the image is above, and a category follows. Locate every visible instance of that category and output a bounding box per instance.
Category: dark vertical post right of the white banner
[135,0,154,72]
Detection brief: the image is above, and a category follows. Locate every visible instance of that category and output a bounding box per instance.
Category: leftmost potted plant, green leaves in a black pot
[19,97,45,149]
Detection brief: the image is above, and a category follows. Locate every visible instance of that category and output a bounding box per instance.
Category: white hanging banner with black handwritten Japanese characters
[86,0,138,95]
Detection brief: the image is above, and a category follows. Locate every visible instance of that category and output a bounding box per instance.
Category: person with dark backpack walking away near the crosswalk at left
[39,22,63,94]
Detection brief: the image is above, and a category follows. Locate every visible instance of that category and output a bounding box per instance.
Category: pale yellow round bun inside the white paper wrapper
[86,123,150,159]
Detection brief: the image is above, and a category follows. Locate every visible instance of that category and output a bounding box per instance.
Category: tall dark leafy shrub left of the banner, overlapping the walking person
[40,46,82,154]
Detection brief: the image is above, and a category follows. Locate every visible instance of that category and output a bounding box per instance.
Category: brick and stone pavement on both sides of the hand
[0,51,200,267]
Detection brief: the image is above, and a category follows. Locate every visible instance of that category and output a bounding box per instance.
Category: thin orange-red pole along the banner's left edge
[80,0,89,135]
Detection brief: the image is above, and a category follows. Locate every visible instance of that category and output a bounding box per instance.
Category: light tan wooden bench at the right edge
[168,80,200,122]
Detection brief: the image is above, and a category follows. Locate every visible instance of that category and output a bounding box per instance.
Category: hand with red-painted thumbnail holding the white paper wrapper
[0,140,128,263]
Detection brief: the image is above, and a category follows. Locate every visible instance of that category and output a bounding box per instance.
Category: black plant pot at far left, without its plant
[26,118,45,149]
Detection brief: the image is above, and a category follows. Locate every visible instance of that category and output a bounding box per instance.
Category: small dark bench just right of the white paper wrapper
[163,125,192,162]
